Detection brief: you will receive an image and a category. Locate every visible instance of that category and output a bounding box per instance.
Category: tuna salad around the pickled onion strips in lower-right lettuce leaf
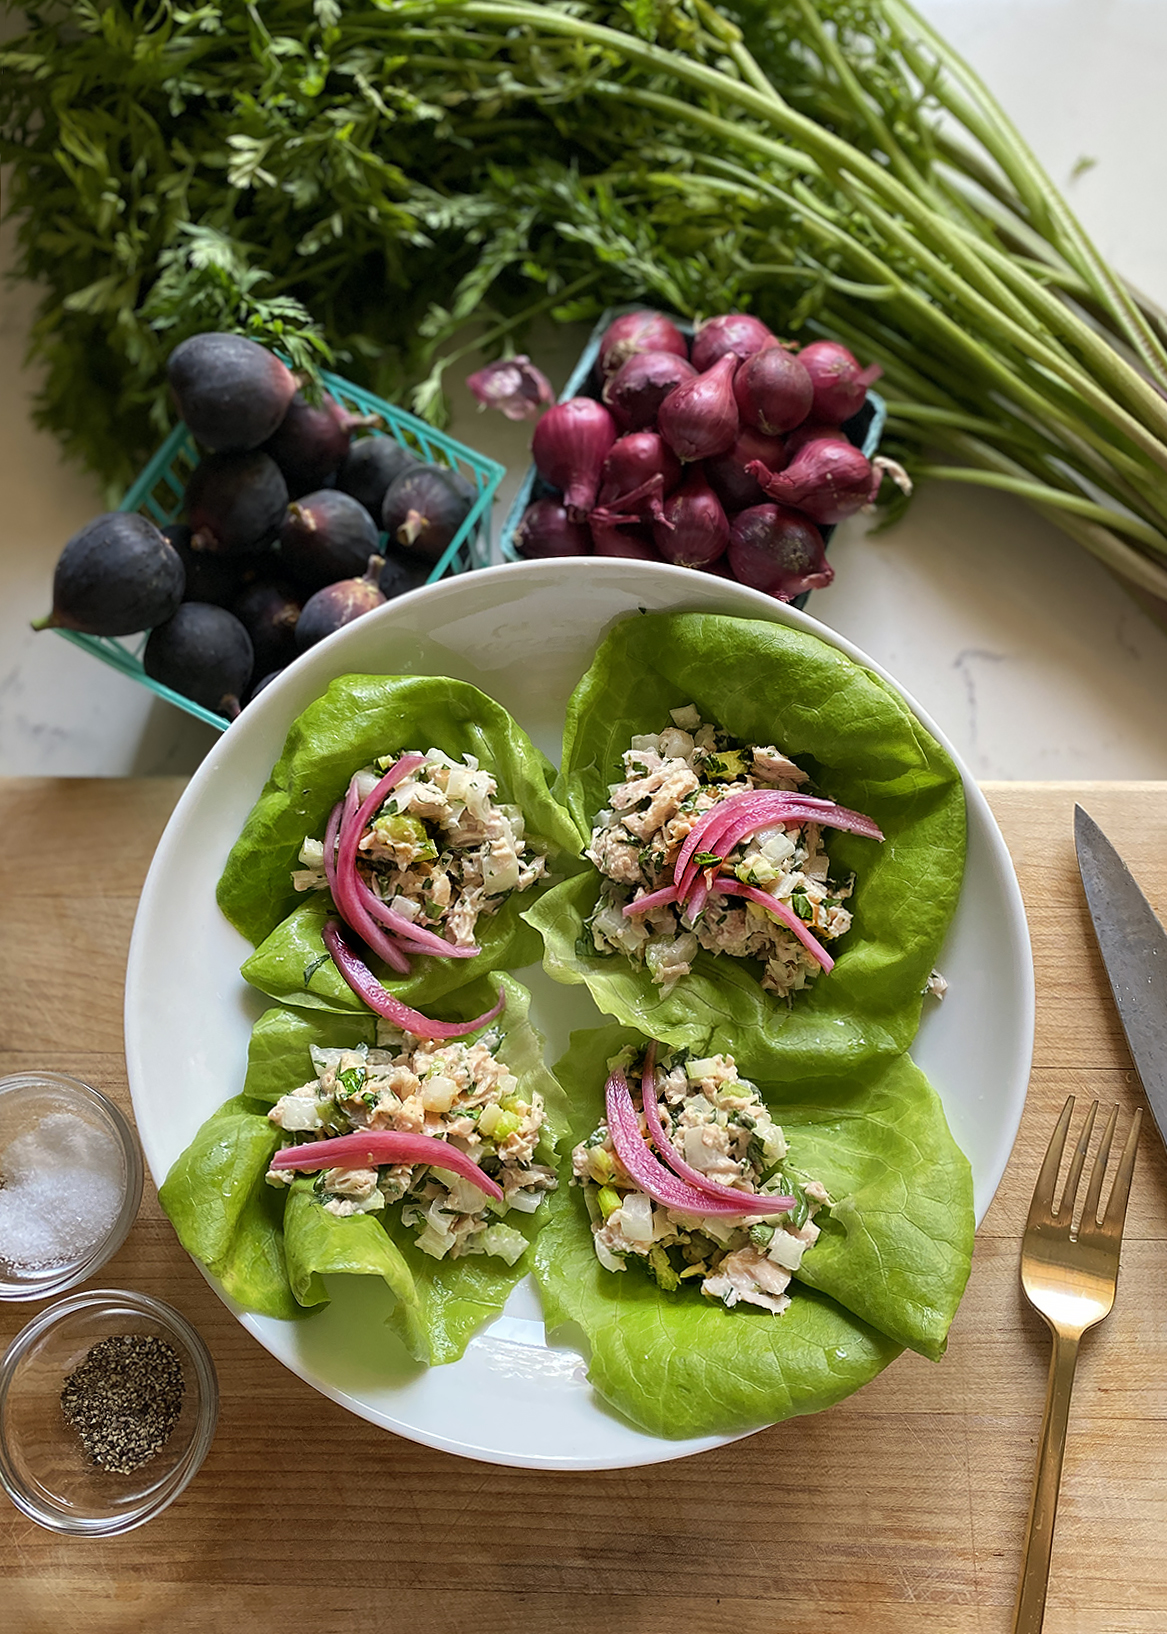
[572,1047,830,1315]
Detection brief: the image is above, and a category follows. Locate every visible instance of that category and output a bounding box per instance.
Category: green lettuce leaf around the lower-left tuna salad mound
[159,975,566,1364]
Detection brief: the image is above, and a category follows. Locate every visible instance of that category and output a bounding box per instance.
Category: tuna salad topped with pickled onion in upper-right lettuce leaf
[585,706,862,997]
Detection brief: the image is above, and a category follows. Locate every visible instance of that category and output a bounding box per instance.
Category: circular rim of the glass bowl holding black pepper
[0,1288,219,1538]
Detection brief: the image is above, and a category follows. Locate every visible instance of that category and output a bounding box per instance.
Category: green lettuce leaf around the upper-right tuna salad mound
[523,613,964,1082]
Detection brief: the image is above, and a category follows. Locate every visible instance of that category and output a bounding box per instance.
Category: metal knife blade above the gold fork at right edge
[1074,806,1167,1144]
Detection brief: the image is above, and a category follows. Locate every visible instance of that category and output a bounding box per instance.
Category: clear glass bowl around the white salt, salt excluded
[0,1072,142,1299]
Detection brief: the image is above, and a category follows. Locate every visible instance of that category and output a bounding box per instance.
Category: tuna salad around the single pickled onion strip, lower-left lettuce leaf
[266,1023,557,1265]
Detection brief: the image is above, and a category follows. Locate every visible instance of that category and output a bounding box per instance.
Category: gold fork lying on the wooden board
[1013,1095,1142,1634]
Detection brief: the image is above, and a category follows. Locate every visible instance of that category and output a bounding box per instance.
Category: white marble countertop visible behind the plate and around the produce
[0,0,1167,778]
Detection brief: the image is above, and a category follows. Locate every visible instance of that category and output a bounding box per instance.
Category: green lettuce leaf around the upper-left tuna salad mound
[217,675,579,1013]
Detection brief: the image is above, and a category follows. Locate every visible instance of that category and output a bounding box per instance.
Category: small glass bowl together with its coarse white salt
[0,1072,142,1299]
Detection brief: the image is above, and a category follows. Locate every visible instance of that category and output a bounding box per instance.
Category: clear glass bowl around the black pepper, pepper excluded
[0,1288,219,1538]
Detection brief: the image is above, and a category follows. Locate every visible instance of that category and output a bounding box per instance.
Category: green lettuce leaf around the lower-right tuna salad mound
[534,1026,973,1438]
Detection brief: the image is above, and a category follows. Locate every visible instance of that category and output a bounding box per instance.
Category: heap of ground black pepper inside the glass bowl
[60,1333,186,1476]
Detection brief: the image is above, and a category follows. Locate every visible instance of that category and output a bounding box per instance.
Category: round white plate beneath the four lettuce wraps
[126,557,1033,1469]
